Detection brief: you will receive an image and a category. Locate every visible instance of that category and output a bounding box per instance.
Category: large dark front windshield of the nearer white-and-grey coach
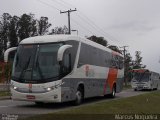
[12,43,63,83]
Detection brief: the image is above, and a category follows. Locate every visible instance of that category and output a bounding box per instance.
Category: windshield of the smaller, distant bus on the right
[134,72,150,82]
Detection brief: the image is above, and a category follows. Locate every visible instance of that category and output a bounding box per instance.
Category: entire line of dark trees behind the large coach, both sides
[0,13,146,84]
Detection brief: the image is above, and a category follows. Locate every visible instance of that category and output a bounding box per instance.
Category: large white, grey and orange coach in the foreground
[4,35,124,105]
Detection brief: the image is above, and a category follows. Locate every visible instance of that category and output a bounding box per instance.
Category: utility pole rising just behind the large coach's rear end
[120,46,128,85]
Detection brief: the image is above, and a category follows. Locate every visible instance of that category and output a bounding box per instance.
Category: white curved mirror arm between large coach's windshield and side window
[57,45,72,62]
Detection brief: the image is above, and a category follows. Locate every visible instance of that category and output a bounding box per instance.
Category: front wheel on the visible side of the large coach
[74,87,83,105]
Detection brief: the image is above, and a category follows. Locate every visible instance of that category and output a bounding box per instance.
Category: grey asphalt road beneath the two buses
[0,89,152,116]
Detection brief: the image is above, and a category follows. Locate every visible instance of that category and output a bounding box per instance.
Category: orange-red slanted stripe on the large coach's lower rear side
[103,68,118,95]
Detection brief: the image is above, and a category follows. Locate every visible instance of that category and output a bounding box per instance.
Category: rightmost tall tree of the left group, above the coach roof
[38,17,51,35]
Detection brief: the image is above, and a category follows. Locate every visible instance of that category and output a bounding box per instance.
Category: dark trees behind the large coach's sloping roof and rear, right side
[87,35,146,85]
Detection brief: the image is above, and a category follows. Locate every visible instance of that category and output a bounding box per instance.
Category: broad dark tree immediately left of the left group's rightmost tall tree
[18,14,37,41]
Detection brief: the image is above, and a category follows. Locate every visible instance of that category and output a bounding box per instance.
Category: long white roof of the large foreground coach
[20,35,123,57]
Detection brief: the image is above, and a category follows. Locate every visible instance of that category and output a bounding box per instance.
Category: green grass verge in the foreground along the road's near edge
[21,91,160,120]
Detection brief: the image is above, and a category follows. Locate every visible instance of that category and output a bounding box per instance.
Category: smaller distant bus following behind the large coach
[131,69,160,91]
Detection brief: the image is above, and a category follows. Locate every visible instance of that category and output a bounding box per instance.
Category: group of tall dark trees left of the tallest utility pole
[0,13,68,60]
